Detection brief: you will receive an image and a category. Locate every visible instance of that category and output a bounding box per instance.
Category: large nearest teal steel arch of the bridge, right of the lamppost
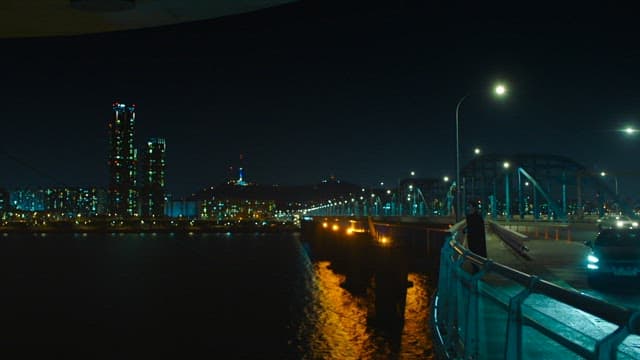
[460,154,635,220]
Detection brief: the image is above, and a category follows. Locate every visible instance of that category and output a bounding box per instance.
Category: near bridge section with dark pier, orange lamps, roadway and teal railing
[306,216,640,359]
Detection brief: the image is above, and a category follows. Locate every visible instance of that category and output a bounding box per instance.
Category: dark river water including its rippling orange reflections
[0,233,434,359]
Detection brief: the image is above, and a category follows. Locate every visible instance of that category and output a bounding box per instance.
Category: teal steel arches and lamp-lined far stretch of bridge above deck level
[303,154,637,222]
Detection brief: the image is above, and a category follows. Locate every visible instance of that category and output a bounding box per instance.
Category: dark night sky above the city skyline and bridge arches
[0,1,640,195]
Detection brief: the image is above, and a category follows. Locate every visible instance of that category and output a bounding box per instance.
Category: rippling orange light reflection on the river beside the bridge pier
[298,239,435,359]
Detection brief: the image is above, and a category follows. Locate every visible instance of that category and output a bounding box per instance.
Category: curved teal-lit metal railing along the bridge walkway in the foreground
[432,228,640,359]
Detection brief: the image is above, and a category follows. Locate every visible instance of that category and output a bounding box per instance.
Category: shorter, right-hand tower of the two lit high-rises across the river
[141,138,167,217]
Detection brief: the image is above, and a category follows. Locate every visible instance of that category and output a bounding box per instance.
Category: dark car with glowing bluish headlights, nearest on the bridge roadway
[585,227,640,285]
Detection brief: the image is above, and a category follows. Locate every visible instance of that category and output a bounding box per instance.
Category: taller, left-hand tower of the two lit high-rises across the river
[108,101,138,217]
